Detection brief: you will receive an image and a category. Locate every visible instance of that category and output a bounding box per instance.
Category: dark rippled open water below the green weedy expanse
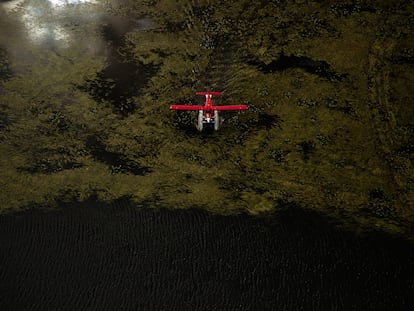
[0,201,414,311]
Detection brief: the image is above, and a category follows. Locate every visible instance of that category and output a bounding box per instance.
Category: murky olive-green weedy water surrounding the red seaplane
[0,0,414,237]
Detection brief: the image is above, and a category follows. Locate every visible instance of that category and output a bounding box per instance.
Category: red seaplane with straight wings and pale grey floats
[170,92,247,131]
